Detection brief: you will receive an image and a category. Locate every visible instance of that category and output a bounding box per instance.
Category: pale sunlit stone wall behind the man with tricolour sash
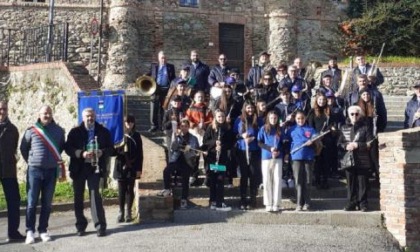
[0,63,77,180]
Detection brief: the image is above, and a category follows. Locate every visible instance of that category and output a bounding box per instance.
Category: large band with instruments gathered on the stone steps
[150,50,398,215]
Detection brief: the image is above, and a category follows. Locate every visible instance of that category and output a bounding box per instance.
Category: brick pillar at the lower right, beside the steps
[379,128,420,251]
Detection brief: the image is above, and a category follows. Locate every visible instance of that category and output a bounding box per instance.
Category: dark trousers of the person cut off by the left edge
[0,178,20,237]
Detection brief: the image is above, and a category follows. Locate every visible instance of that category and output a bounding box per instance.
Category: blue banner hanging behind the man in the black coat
[77,90,125,146]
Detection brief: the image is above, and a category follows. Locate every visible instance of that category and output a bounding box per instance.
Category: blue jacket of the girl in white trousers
[258,126,283,160]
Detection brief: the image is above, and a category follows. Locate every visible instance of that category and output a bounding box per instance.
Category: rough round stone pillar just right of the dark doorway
[268,9,297,66]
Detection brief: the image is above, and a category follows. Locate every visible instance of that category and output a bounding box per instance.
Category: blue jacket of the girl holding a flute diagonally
[287,124,316,160]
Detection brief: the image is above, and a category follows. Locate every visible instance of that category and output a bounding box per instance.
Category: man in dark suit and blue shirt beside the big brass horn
[148,51,175,132]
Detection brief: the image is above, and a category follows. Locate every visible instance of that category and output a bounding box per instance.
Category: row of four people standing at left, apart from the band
[0,101,143,244]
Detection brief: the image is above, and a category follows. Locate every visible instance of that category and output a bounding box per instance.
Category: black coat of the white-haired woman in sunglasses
[338,118,373,170]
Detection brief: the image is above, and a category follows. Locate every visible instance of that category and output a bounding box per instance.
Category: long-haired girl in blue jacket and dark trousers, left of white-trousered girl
[233,101,263,210]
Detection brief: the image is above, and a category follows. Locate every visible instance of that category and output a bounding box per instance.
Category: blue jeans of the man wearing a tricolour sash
[26,166,57,233]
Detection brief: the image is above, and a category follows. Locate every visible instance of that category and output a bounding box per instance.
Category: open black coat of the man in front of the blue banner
[65,122,114,179]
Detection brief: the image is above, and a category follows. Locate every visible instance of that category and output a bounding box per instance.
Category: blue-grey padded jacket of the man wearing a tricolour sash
[20,121,65,169]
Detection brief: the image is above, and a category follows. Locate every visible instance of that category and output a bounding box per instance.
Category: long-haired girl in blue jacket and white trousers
[258,110,283,212]
